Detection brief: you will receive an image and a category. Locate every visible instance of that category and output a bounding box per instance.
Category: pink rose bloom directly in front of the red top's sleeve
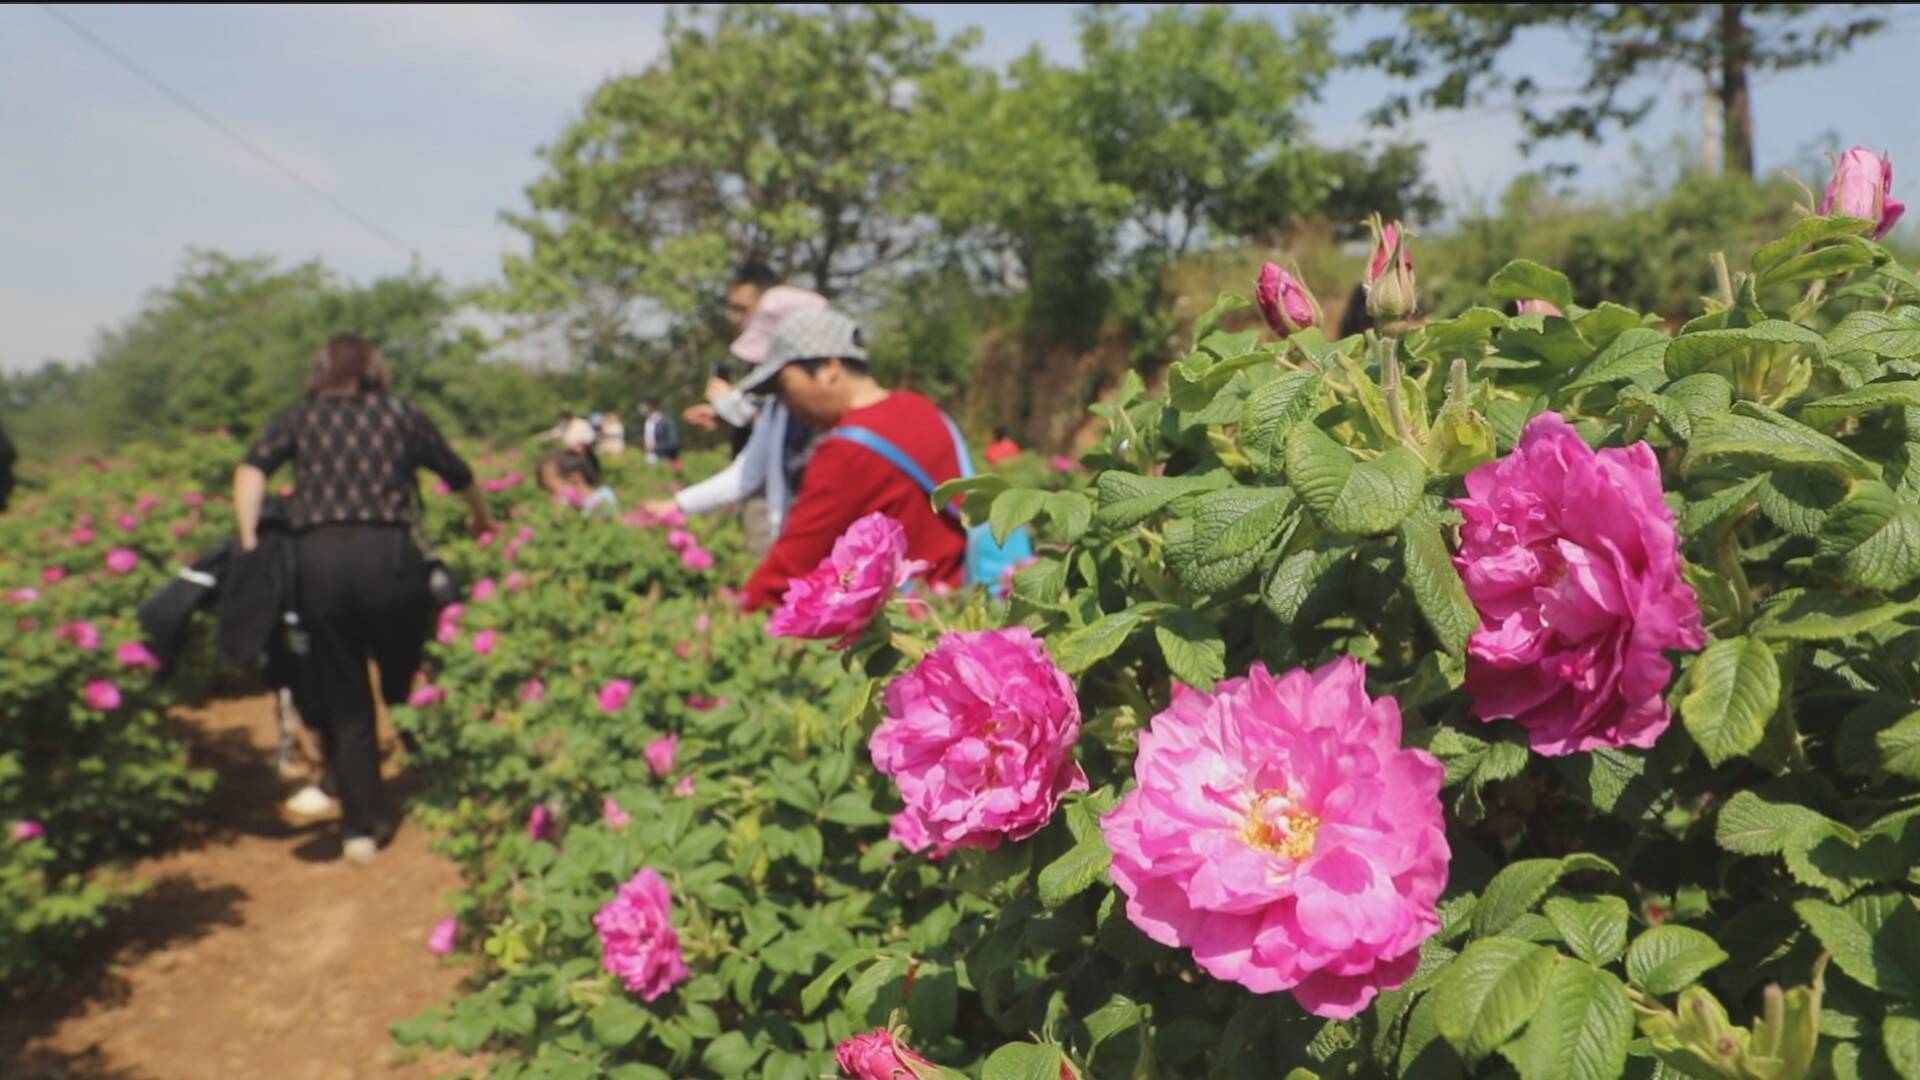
[766,511,927,648]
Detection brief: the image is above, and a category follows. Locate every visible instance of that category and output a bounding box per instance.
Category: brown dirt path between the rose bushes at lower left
[0,698,472,1080]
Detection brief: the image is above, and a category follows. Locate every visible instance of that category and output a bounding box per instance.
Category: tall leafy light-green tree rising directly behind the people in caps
[503,4,964,330]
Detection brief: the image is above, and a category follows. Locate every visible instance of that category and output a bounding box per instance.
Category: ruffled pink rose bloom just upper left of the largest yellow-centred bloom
[868,626,1087,853]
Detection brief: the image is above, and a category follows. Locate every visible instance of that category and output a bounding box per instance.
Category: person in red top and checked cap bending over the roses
[739,307,966,609]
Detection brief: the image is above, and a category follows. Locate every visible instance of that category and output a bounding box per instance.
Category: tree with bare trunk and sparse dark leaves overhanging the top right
[1348,4,1885,177]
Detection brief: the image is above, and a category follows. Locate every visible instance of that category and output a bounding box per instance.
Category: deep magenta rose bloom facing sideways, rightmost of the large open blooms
[1453,413,1707,755]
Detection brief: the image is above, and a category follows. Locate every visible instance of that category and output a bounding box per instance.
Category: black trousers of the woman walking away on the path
[294,525,432,838]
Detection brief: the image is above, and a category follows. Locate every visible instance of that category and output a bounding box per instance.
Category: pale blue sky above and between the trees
[0,4,1920,369]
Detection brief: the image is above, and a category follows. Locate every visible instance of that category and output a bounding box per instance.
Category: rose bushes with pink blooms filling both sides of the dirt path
[11,188,1920,1080]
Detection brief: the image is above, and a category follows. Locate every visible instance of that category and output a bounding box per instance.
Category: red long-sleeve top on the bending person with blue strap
[747,390,966,609]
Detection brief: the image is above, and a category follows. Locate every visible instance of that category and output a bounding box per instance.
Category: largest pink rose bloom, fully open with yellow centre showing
[1102,657,1448,1019]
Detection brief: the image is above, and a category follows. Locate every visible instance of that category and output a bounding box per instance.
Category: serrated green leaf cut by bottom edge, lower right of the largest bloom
[1501,959,1634,1080]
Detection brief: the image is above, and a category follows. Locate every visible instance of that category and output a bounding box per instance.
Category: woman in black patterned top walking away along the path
[234,336,493,863]
